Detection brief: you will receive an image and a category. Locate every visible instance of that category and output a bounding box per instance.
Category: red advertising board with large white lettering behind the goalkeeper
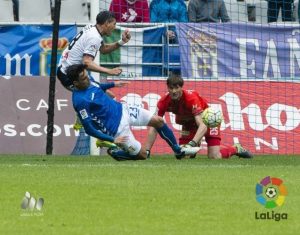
[118,79,300,154]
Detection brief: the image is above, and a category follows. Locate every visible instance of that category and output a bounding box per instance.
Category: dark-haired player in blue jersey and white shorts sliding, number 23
[67,64,200,160]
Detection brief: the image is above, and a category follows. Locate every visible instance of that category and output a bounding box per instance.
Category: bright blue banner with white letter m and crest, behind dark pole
[0,25,77,76]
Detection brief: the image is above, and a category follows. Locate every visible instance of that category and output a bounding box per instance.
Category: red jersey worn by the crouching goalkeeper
[157,90,208,131]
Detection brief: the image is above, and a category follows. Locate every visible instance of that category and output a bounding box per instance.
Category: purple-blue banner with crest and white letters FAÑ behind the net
[176,23,300,81]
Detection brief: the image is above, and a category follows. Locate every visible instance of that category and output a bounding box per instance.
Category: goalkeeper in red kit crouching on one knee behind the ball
[146,75,253,159]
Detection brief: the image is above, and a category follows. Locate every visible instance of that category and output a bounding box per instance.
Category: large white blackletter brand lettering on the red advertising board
[121,92,300,132]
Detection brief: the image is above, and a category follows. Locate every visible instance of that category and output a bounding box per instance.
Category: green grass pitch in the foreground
[0,155,300,235]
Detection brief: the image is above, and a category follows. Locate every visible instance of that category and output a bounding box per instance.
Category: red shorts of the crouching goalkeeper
[179,127,221,146]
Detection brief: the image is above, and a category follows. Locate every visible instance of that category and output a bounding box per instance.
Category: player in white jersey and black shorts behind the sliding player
[57,11,131,90]
